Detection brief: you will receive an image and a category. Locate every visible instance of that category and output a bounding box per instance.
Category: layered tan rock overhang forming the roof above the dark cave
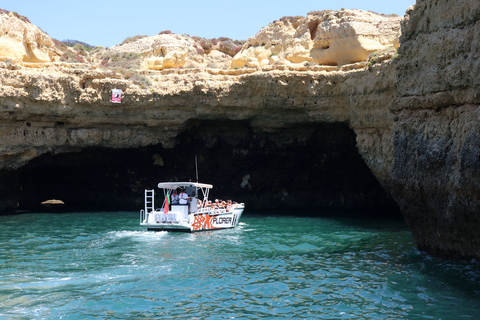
[0,57,393,216]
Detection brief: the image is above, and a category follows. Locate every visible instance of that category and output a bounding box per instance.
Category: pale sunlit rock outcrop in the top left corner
[0,11,59,62]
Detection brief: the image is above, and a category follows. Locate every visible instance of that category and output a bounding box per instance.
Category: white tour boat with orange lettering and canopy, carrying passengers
[140,182,245,232]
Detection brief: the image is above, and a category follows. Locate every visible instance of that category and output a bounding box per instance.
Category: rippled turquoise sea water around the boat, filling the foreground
[0,212,480,319]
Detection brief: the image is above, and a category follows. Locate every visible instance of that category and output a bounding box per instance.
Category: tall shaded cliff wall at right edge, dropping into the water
[391,0,480,259]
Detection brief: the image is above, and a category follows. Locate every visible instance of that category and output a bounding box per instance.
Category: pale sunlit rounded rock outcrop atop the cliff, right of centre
[232,9,401,68]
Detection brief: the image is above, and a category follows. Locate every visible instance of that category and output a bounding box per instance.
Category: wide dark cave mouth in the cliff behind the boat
[18,120,399,215]
